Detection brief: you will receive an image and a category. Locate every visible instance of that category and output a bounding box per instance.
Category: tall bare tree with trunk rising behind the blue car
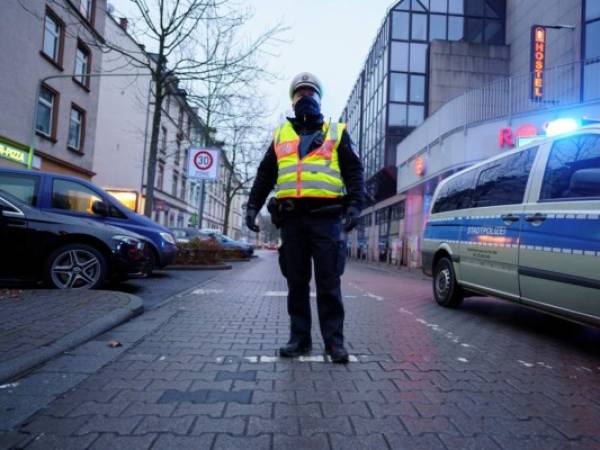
[98,0,283,217]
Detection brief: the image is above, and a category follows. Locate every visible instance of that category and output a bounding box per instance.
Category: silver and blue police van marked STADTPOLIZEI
[422,123,600,325]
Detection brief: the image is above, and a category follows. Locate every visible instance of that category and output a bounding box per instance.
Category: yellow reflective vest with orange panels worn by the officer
[273,121,346,199]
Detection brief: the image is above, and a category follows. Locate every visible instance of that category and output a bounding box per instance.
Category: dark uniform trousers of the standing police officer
[279,214,346,347]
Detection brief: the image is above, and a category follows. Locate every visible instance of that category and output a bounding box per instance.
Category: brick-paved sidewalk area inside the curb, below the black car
[0,289,135,362]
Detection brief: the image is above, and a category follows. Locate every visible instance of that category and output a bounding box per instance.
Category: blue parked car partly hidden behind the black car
[0,169,177,271]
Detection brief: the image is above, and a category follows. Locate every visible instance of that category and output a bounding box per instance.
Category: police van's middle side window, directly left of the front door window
[473,147,537,208]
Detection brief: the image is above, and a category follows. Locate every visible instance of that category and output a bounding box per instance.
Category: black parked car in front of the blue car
[0,190,148,289]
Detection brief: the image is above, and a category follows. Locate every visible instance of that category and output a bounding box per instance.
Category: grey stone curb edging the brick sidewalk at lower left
[0,294,144,382]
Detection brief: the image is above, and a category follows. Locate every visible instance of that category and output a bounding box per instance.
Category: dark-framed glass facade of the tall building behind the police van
[341,0,506,201]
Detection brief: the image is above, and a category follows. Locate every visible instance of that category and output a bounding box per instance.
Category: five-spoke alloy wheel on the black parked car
[50,248,103,289]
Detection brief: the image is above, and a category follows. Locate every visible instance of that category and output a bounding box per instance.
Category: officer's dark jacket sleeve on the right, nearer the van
[338,130,365,209]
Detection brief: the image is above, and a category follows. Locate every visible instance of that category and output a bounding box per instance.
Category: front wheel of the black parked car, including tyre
[44,244,107,289]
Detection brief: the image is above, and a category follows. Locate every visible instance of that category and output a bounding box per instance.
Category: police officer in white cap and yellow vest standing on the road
[246,73,364,363]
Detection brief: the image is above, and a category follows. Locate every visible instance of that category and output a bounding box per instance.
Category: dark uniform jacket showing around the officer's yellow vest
[248,116,365,211]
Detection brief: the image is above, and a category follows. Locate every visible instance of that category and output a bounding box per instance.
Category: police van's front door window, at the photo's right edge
[540,134,600,200]
